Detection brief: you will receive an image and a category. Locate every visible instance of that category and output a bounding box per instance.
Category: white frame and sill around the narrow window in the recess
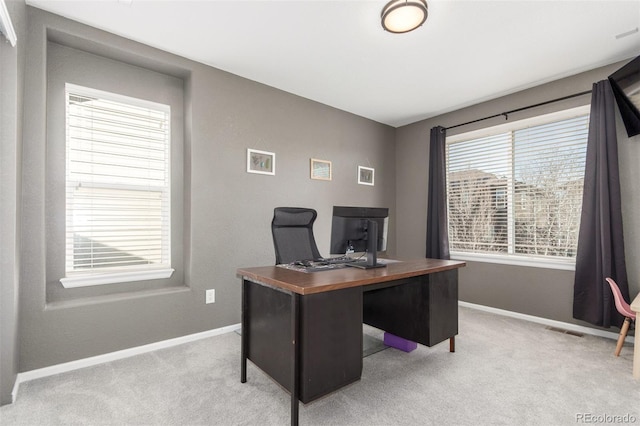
[60,83,175,288]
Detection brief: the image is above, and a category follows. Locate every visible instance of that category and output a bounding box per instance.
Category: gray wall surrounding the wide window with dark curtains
[396,61,640,326]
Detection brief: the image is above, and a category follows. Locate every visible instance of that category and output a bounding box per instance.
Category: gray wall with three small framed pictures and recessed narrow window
[19,8,395,371]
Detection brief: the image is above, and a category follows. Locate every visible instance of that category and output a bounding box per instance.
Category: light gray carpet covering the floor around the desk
[0,308,640,426]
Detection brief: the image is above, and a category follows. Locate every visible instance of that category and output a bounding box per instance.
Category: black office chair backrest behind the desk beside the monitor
[271,207,321,264]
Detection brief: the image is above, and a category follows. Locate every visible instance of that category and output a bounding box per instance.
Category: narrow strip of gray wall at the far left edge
[0,1,26,405]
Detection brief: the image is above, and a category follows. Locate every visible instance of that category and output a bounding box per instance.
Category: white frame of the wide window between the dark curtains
[445,105,590,271]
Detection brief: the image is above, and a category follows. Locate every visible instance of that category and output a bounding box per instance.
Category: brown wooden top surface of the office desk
[237,259,466,295]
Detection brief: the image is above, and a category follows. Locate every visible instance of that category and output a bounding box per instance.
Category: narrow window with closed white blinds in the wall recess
[63,85,171,286]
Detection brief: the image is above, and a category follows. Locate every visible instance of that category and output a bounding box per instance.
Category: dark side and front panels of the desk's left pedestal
[245,281,362,403]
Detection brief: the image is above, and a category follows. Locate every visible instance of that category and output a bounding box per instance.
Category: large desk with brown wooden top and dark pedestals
[237,259,465,425]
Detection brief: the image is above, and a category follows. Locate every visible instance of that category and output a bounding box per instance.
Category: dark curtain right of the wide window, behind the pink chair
[573,80,629,327]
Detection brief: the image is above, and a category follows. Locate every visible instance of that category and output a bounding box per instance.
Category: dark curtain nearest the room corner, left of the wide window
[427,126,450,259]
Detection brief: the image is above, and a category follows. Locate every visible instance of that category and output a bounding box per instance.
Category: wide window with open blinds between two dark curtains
[446,109,589,262]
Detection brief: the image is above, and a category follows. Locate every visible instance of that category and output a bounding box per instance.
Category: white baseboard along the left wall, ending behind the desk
[11,323,241,402]
